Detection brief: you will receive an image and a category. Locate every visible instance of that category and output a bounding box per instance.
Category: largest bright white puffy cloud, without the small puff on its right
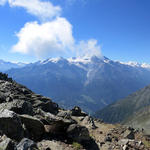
[12,17,74,57]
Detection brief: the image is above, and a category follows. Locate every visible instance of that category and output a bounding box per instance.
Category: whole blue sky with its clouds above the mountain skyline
[0,0,150,63]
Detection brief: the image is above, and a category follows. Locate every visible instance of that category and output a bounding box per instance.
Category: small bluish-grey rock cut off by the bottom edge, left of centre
[16,138,38,150]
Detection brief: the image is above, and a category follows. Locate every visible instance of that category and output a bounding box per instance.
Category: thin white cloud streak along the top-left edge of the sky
[0,0,61,20]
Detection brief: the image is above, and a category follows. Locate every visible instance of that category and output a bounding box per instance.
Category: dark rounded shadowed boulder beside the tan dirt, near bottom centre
[67,124,90,142]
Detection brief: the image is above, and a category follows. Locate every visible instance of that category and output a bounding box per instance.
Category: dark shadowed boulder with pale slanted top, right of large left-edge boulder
[20,115,44,140]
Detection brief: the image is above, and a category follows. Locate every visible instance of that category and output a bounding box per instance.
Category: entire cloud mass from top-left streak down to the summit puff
[0,0,101,58]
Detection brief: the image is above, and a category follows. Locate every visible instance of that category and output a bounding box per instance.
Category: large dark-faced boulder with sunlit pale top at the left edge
[0,109,24,140]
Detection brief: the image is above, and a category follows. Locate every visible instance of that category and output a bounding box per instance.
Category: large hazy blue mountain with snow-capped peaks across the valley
[7,57,150,112]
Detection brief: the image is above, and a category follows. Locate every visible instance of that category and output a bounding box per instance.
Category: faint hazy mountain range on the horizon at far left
[0,60,25,72]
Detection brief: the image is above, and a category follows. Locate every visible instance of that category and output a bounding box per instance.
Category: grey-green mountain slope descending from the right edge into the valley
[96,85,150,134]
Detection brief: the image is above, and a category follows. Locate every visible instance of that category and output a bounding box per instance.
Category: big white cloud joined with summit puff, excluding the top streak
[12,17,101,58]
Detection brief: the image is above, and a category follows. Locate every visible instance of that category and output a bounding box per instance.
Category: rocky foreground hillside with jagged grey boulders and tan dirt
[0,80,150,150]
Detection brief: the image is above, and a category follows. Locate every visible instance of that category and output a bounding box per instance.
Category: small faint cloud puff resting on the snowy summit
[77,39,102,57]
